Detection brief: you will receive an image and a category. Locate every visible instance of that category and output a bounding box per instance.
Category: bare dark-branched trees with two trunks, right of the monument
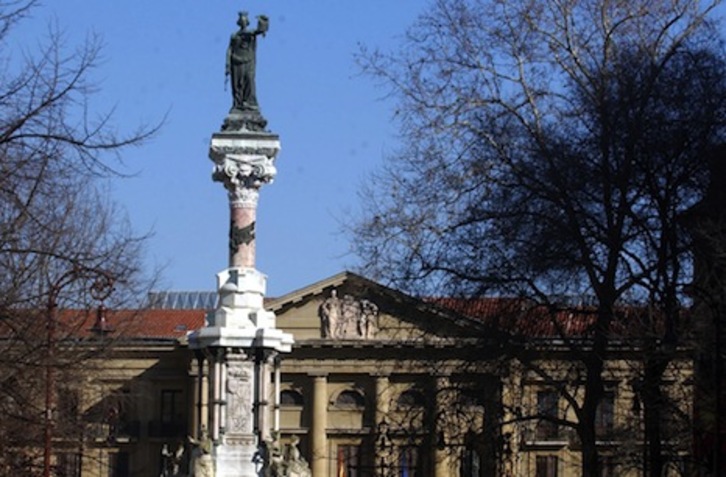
[353,0,726,476]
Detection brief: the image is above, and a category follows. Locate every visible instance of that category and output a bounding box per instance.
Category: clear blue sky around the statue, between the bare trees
[11,0,426,296]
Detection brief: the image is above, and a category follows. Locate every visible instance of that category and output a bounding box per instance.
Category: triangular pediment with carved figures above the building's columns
[266,272,476,345]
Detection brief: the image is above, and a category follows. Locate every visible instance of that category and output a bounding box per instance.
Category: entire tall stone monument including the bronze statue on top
[189,12,293,477]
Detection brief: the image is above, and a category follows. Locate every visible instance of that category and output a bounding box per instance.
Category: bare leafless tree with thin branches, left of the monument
[0,0,158,476]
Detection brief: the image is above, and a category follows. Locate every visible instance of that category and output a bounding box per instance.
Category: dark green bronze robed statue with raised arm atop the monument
[225,12,269,111]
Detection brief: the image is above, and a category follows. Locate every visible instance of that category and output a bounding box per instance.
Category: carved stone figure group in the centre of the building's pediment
[318,290,378,339]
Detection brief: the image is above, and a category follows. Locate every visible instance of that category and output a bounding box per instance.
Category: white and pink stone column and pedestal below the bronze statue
[189,129,293,477]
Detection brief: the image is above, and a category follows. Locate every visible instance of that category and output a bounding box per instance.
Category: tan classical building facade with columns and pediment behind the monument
[25,273,692,477]
